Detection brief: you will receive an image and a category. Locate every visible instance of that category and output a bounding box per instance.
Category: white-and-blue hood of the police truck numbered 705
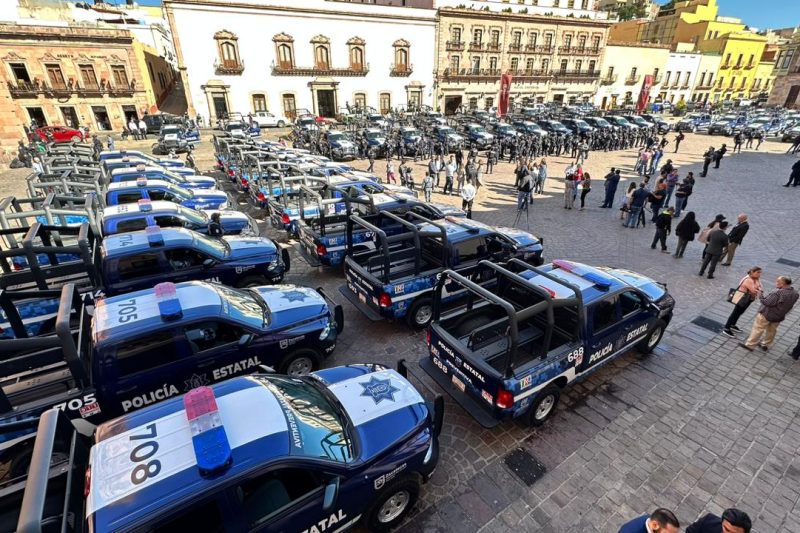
[256,285,328,330]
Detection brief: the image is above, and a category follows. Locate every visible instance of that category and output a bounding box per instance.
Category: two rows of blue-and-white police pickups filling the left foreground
[0,132,674,532]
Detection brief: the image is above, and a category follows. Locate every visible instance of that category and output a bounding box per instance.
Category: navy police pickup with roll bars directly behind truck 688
[339,212,542,328]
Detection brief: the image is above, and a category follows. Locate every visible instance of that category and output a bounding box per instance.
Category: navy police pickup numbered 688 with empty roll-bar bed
[420,259,675,428]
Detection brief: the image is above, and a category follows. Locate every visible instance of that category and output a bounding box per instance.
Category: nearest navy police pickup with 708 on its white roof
[10,362,443,533]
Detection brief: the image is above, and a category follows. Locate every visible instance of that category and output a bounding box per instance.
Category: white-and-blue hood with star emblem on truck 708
[312,365,428,460]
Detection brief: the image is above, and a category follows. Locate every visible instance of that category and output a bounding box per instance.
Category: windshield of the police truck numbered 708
[256,375,353,463]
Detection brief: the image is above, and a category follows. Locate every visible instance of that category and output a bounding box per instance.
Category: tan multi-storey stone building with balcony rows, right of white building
[434,2,610,114]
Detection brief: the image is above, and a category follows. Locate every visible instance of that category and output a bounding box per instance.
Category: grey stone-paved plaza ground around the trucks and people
[6,127,800,533]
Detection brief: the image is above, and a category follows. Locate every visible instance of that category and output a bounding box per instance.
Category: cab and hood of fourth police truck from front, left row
[102,200,259,236]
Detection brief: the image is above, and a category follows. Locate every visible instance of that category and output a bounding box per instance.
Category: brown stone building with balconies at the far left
[0,24,149,149]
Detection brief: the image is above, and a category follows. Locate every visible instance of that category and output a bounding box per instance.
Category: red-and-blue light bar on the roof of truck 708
[183,387,233,476]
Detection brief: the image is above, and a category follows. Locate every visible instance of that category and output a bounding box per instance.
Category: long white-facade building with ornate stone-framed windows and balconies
[164,0,436,124]
